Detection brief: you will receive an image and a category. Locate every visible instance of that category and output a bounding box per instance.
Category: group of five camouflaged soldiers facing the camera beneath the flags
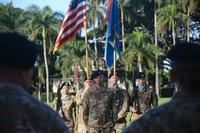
[53,70,158,133]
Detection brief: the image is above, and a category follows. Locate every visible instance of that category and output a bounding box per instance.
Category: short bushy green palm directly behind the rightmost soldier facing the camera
[122,28,158,72]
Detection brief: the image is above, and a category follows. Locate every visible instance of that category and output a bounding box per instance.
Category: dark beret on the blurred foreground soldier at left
[0,32,37,69]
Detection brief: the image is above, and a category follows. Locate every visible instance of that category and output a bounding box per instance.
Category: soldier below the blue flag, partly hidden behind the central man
[109,73,128,133]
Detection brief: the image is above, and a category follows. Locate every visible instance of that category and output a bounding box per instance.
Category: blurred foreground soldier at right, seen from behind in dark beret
[124,42,200,133]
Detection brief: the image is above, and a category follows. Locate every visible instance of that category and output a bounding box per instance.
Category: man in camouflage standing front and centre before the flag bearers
[83,71,113,133]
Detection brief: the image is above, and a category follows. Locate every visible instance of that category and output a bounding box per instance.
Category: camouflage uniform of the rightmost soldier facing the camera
[131,86,158,121]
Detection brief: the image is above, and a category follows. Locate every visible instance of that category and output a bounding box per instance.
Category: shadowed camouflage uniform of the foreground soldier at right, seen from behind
[124,92,200,133]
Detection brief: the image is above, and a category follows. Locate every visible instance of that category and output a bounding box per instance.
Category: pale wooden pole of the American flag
[84,22,89,79]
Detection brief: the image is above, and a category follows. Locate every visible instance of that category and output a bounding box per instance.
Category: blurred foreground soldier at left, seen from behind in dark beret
[0,33,69,133]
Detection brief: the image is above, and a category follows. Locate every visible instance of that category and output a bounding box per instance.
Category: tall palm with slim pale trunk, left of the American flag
[21,6,59,103]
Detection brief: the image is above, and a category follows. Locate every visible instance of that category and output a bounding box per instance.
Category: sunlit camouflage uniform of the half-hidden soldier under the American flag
[76,89,86,133]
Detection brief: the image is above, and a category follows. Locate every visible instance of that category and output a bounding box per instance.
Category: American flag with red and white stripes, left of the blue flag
[54,0,86,52]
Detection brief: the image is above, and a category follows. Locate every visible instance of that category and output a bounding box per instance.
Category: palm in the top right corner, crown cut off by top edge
[180,0,199,42]
